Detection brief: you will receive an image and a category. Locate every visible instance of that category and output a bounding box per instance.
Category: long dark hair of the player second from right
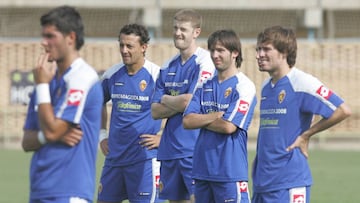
[208,30,243,68]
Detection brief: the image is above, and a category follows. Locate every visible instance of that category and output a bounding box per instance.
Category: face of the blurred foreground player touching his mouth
[41,25,71,62]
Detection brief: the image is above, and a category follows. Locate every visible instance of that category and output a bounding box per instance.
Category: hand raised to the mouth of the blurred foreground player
[33,53,56,84]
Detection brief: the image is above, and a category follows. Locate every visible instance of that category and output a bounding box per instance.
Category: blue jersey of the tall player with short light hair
[153,47,215,160]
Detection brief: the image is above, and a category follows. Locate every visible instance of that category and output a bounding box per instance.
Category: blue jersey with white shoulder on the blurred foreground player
[24,58,103,200]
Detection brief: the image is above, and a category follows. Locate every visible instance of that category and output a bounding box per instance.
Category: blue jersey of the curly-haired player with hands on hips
[102,60,161,166]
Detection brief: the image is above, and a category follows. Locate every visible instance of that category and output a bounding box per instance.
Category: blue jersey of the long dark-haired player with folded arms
[184,72,257,182]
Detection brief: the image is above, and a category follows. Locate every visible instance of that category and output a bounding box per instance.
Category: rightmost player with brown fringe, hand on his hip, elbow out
[252,26,351,203]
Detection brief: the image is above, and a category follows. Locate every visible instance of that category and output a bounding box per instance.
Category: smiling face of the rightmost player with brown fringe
[256,44,286,73]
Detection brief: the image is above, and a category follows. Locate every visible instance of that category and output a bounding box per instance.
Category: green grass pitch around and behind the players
[0,149,360,203]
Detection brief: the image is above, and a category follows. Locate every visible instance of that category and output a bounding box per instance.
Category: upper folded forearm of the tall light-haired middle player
[161,94,192,112]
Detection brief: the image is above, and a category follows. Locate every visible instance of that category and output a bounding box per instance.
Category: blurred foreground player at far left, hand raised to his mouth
[23,6,103,203]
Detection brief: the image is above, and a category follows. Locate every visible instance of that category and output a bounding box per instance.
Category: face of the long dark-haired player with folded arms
[210,42,237,72]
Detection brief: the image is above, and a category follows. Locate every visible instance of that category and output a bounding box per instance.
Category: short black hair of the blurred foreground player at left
[40,6,84,50]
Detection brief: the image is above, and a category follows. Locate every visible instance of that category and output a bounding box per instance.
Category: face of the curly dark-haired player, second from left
[119,34,147,67]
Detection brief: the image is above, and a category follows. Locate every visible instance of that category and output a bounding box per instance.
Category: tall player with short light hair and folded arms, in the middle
[151,9,215,202]
